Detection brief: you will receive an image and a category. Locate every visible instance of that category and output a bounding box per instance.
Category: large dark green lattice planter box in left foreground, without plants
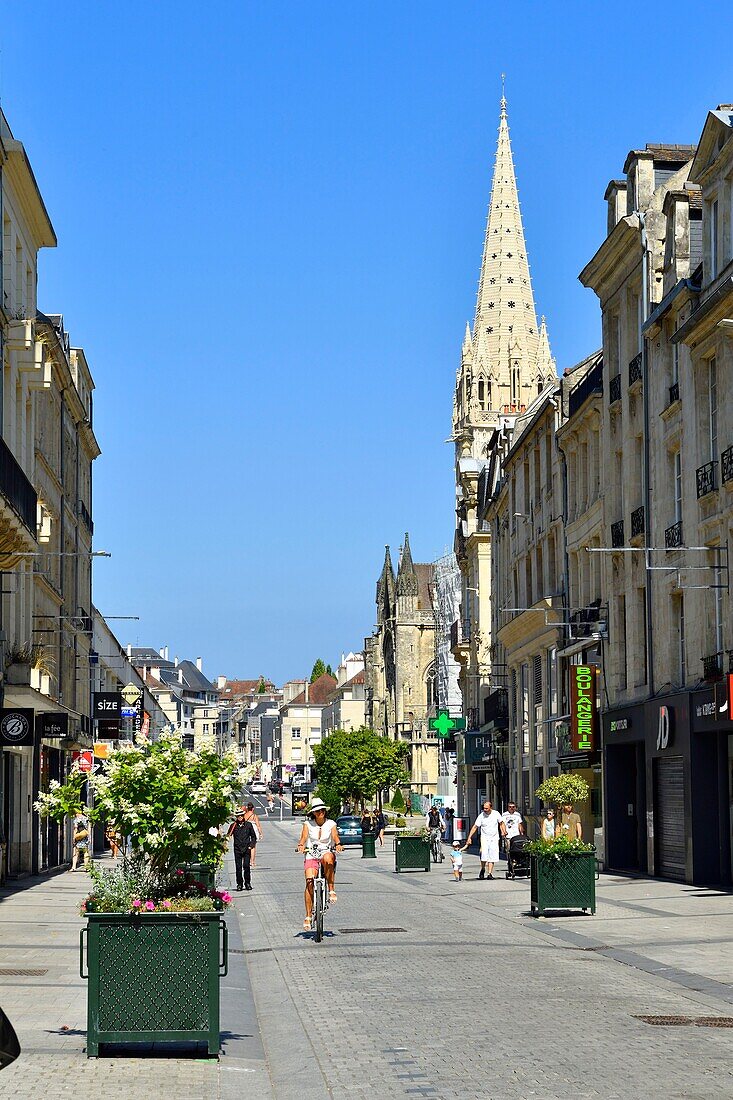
[79,912,228,1058]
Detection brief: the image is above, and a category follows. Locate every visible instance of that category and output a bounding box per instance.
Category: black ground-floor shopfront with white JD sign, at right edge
[603,685,733,886]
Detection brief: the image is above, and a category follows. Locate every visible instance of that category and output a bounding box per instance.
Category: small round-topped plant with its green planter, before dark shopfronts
[526,773,595,916]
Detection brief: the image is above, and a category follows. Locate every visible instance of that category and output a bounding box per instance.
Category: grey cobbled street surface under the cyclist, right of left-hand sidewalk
[243,823,733,1100]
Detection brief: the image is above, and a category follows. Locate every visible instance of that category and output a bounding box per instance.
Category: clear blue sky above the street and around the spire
[0,0,733,681]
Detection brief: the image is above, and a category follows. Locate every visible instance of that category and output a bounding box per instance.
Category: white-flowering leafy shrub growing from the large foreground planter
[35,734,247,876]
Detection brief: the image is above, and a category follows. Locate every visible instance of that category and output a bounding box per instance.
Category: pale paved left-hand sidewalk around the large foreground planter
[0,867,271,1100]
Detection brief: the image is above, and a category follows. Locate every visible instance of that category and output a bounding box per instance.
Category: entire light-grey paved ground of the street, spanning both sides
[0,821,733,1100]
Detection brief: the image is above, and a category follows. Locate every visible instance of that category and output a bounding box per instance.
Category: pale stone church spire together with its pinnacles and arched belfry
[452,96,557,468]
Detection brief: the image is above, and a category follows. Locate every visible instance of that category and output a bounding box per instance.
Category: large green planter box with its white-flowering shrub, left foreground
[36,734,240,1057]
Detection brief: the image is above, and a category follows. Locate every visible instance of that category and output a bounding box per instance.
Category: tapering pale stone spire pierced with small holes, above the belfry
[473,86,539,405]
